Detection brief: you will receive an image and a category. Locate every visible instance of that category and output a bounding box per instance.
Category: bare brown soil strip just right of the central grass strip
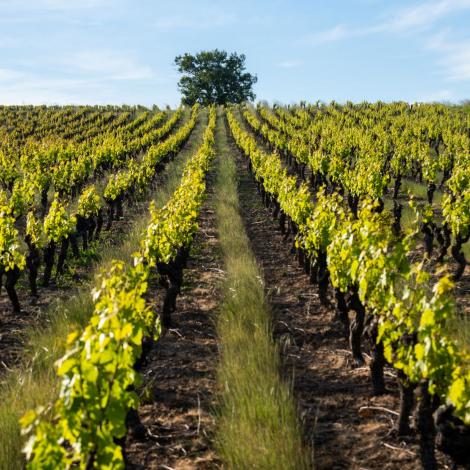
[230,123,448,469]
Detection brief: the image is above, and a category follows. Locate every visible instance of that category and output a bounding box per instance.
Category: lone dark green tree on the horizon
[175,49,258,106]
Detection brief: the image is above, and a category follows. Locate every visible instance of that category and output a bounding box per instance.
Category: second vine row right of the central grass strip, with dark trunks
[243,107,470,280]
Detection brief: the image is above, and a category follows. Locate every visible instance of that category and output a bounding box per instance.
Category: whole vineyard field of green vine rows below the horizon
[0,102,470,470]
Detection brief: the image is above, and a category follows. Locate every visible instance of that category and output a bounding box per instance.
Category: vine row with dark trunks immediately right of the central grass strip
[227,110,470,468]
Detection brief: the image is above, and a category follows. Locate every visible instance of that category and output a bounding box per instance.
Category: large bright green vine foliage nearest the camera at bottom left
[21,261,154,469]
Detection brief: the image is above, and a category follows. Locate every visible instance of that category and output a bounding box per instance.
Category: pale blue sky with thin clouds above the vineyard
[0,0,470,106]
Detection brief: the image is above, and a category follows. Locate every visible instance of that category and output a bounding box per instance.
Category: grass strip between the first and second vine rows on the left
[0,108,207,470]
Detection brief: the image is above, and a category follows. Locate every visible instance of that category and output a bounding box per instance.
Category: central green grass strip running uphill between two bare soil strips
[216,108,312,470]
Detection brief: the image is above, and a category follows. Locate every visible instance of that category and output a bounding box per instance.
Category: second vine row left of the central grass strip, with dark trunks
[0,108,197,312]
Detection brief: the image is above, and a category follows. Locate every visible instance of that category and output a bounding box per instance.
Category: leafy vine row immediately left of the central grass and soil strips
[21,108,216,469]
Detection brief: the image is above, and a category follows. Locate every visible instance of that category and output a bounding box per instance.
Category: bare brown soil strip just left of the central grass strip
[127,127,223,469]
